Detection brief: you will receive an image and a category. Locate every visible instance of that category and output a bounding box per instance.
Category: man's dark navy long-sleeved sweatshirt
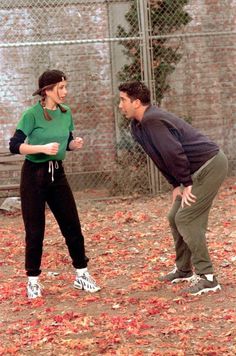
[131,105,219,187]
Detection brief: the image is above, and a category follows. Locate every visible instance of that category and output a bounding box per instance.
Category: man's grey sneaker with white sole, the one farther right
[182,274,221,295]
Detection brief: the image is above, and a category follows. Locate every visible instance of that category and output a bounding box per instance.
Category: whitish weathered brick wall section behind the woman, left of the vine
[0,1,116,178]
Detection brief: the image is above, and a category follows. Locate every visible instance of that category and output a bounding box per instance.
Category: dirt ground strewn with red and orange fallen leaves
[0,178,236,356]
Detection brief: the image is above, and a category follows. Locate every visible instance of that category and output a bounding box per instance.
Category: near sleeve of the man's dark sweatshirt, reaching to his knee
[143,119,192,187]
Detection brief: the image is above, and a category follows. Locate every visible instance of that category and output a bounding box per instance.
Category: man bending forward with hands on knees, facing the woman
[119,81,228,295]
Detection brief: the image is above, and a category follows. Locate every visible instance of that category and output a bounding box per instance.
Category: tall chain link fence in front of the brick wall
[0,0,236,198]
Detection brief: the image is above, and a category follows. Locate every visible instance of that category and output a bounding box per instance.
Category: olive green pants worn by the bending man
[168,151,228,275]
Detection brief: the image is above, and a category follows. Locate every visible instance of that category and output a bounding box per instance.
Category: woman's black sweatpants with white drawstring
[20,159,88,276]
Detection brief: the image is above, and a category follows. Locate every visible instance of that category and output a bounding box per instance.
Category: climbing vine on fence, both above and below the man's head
[111,0,191,194]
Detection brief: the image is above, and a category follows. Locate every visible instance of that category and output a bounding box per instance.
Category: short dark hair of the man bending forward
[118,81,151,105]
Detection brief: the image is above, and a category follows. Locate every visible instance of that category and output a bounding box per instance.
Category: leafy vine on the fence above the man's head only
[118,0,191,104]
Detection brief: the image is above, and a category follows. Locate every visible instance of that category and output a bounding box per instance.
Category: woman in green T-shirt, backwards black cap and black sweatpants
[10,70,100,298]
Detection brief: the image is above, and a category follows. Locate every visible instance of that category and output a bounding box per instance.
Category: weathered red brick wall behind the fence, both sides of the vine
[0,0,236,192]
